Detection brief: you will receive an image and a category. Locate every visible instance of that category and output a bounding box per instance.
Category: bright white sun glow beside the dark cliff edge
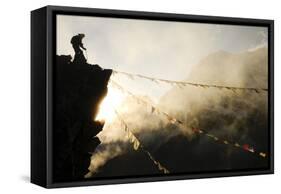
[95,84,124,122]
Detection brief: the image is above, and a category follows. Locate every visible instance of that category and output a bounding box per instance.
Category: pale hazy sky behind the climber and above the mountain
[57,15,268,100]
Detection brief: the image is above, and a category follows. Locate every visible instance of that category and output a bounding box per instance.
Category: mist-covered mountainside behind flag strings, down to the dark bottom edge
[89,47,269,178]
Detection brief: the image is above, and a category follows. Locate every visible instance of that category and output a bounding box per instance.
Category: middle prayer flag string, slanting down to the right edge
[110,80,267,158]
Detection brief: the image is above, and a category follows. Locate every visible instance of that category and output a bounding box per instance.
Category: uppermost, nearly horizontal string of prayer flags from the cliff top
[113,70,268,93]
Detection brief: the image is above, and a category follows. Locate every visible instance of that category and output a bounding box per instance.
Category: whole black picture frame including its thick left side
[31,6,274,188]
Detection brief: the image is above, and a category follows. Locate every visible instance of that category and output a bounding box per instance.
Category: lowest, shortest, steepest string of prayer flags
[114,109,170,174]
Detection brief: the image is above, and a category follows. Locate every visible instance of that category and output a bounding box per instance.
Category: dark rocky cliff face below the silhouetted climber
[53,55,112,182]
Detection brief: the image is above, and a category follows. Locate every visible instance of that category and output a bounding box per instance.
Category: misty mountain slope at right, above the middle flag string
[156,47,268,164]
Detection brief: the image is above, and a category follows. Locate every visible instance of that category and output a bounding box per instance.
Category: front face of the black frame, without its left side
[42,6,274,188]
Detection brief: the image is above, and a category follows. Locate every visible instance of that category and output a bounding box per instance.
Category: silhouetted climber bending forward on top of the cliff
[71,34,87,63]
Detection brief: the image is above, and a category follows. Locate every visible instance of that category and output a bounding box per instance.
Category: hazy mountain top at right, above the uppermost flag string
[188,47,268,87]
